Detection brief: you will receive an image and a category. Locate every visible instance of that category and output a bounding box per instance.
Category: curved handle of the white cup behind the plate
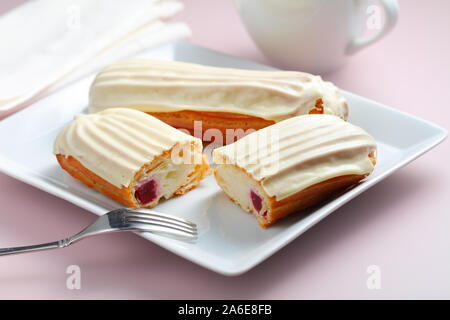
[347,0,398,54]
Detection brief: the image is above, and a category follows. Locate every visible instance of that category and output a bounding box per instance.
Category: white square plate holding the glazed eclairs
[0,43,447,275]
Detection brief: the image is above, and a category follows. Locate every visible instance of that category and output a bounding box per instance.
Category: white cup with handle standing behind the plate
[235,0,398,74]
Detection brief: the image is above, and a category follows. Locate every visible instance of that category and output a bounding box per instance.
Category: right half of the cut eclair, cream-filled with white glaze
[213,115,377,228]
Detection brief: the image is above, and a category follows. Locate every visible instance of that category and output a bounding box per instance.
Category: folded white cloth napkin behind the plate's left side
[0,0,190,119]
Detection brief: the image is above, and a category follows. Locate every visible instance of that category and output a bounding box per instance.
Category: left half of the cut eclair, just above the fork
[53,108,211,208]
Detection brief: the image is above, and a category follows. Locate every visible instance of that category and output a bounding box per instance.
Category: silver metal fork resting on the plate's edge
[0,209,197,256]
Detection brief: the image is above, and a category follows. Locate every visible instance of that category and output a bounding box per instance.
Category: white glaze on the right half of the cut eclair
[213,115,377,201]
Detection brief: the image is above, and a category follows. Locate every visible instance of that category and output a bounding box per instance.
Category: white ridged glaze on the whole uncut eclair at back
[89,59,348,122]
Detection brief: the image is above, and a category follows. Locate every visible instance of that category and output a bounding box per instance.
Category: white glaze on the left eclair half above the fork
[53,108,202,188]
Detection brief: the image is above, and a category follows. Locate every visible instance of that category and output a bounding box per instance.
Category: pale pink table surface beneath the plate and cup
[0,0,450,299]
